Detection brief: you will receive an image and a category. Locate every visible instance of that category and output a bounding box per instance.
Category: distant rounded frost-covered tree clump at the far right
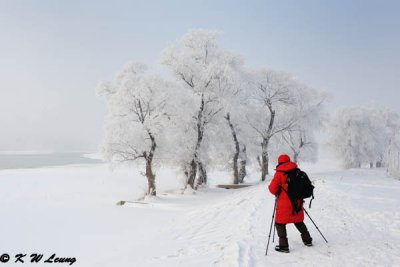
[329,105,397,168]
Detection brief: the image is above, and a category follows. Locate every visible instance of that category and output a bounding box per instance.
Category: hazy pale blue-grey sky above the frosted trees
[0,0,400,151]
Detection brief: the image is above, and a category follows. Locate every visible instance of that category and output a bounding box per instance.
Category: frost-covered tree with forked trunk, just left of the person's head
[247,69,296,181]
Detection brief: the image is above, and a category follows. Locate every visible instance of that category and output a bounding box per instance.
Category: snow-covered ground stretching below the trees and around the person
[0,164,400,267]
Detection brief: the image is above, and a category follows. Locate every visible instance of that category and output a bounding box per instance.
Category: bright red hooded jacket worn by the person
[268,161,304,224]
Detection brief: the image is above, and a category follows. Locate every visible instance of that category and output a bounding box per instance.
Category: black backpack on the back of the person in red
[284,168,314,216]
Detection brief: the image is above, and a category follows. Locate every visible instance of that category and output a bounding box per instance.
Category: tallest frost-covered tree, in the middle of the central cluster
[161,29,242,191]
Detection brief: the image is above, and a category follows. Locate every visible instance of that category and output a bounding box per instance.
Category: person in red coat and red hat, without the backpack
[268,154,312,253]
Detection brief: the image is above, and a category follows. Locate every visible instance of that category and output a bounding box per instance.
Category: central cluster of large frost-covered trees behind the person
[98,29,326,195]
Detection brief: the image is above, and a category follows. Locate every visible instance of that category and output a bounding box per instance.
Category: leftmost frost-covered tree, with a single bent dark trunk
[97,64,169,195]
